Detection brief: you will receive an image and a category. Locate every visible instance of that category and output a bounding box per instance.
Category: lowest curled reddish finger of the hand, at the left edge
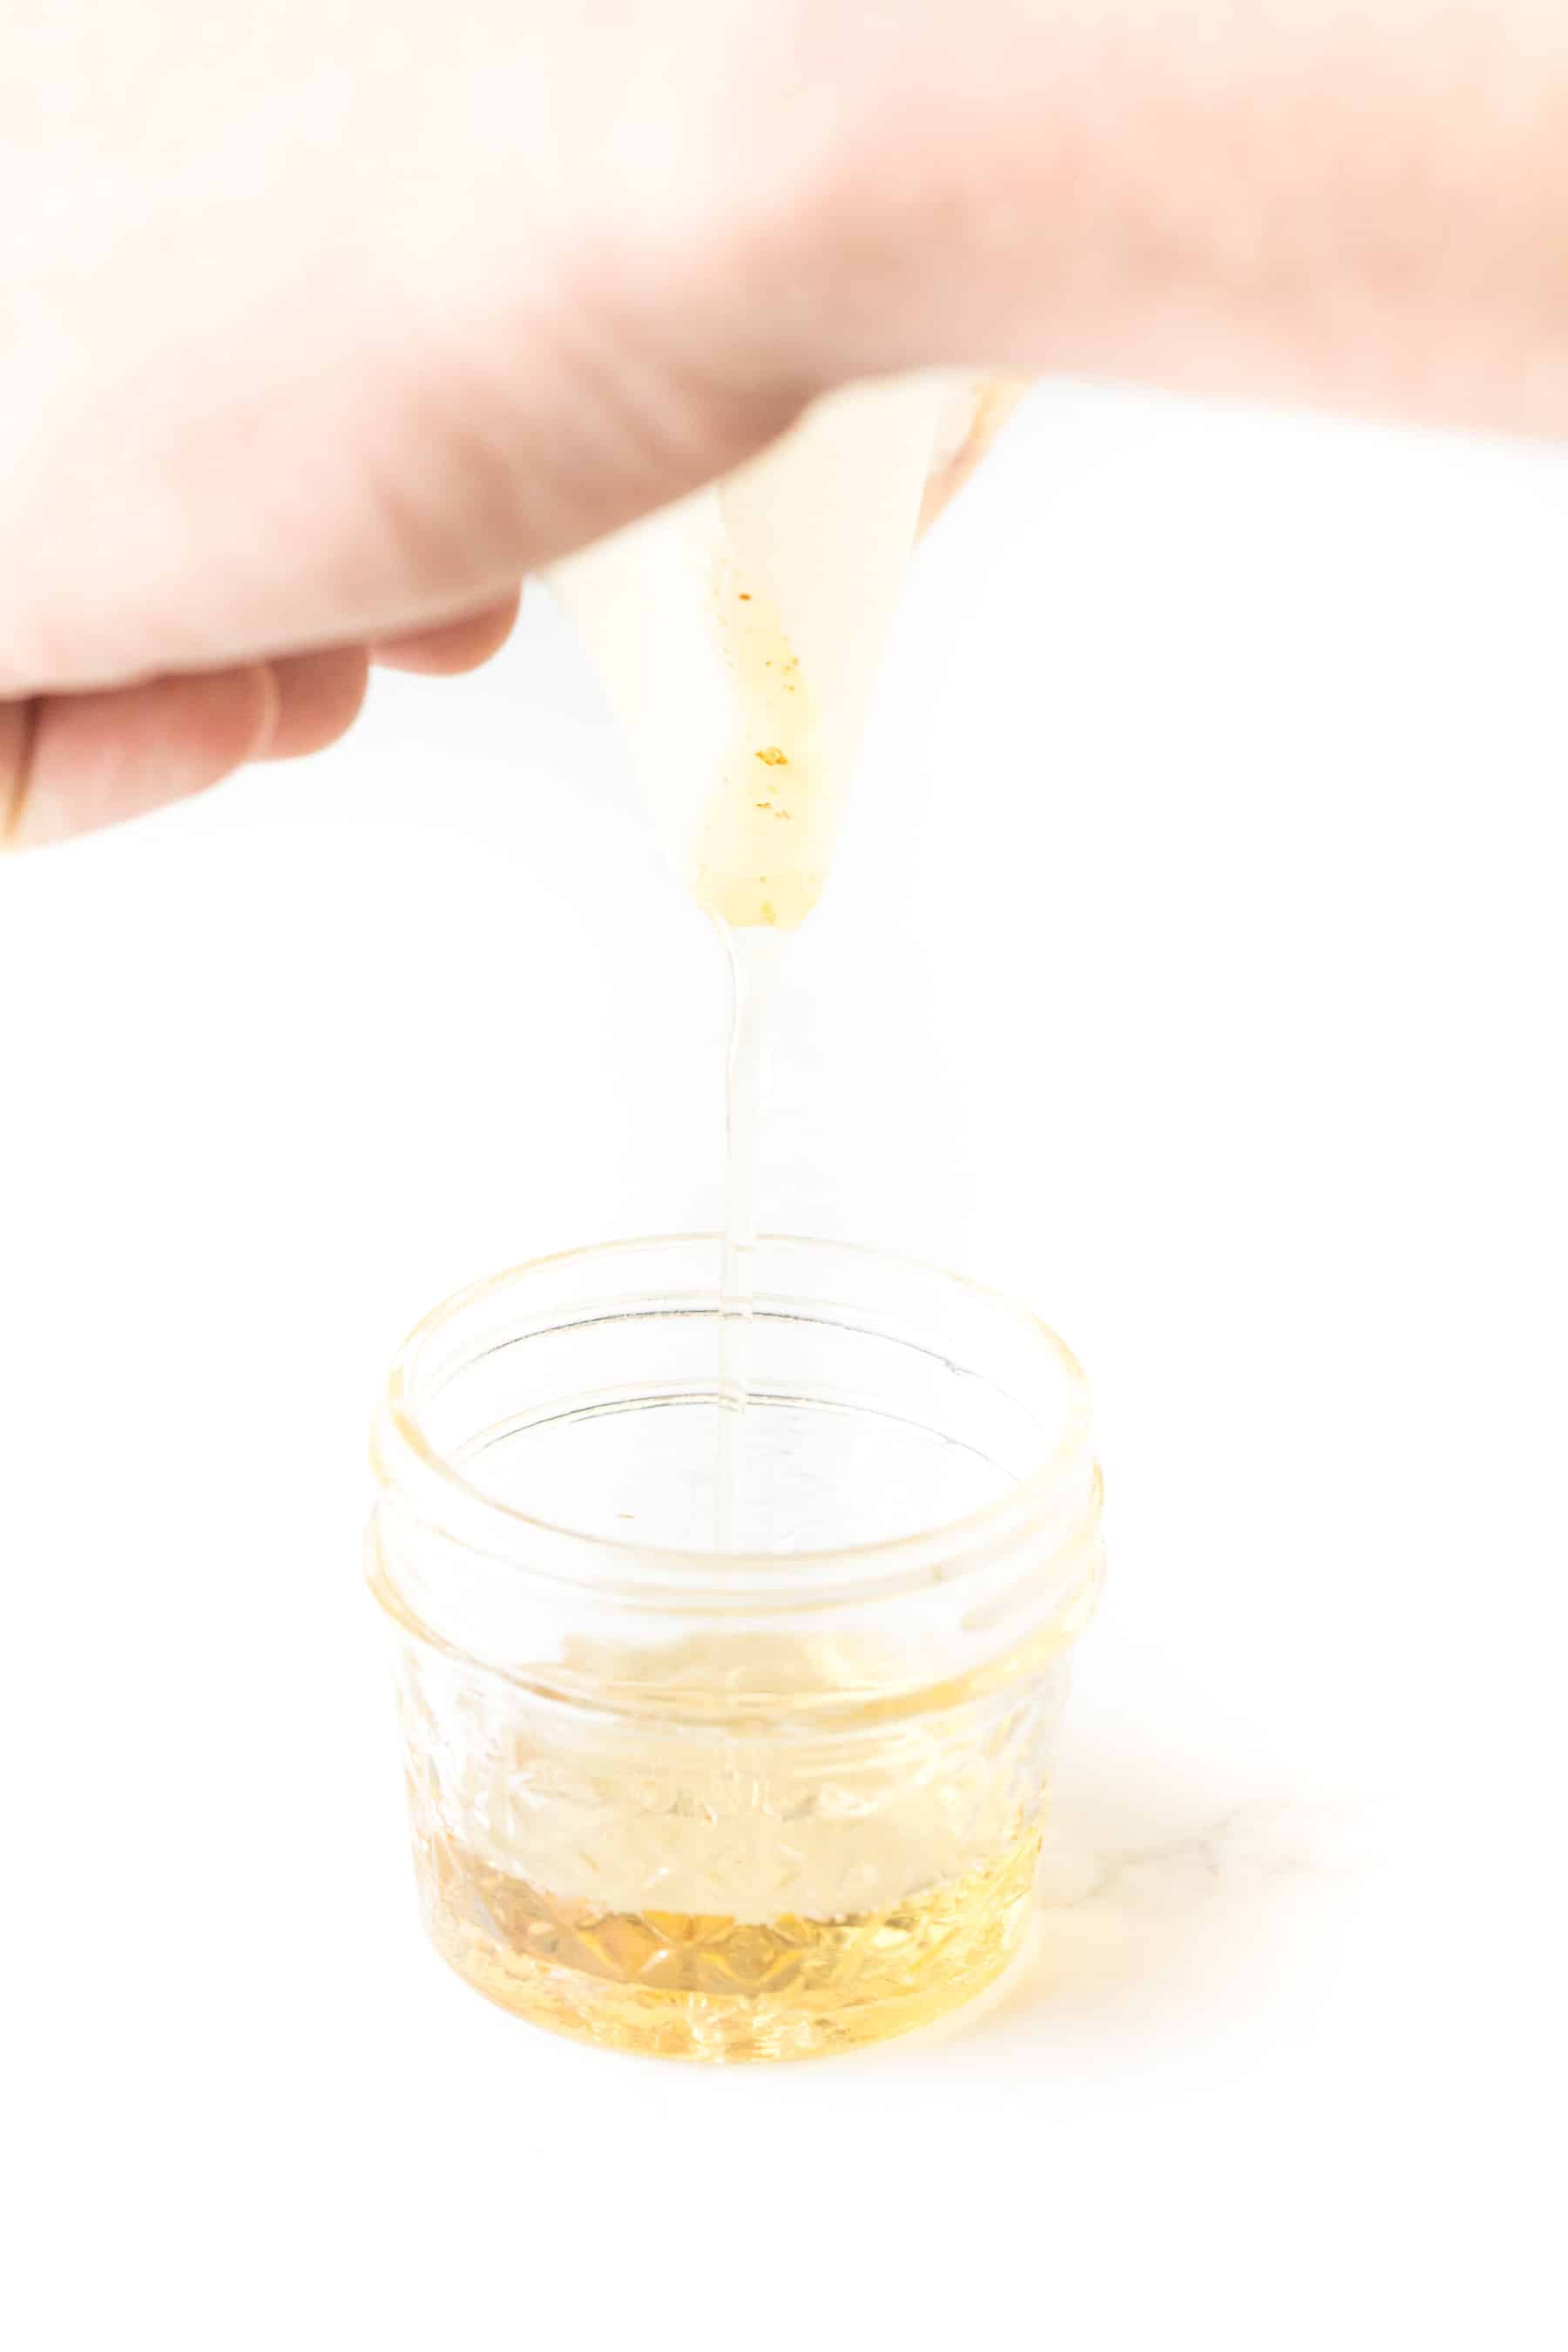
[0,663,280,849]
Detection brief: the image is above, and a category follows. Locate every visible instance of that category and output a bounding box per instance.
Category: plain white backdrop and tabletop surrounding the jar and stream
[0,390,1568,2352]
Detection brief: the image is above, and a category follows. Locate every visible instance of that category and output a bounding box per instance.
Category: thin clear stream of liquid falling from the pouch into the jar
[713,922,783,1552]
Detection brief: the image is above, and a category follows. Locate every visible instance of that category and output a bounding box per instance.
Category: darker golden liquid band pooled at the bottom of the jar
[418,1825,1039,2060]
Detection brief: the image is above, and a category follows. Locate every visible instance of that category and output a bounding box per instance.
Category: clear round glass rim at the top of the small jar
[371,1233,1093,1604]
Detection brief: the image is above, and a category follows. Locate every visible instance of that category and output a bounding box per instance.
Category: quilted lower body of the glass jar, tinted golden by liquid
[388,1571,1072,2060]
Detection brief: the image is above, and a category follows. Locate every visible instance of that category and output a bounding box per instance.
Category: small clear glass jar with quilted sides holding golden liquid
[369,1240,1103,2058]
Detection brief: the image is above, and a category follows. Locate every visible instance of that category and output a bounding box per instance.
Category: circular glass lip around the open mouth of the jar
[371,1235,1098,1606]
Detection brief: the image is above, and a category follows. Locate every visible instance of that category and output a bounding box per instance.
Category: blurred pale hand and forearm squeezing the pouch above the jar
[0,0,1568,842]
